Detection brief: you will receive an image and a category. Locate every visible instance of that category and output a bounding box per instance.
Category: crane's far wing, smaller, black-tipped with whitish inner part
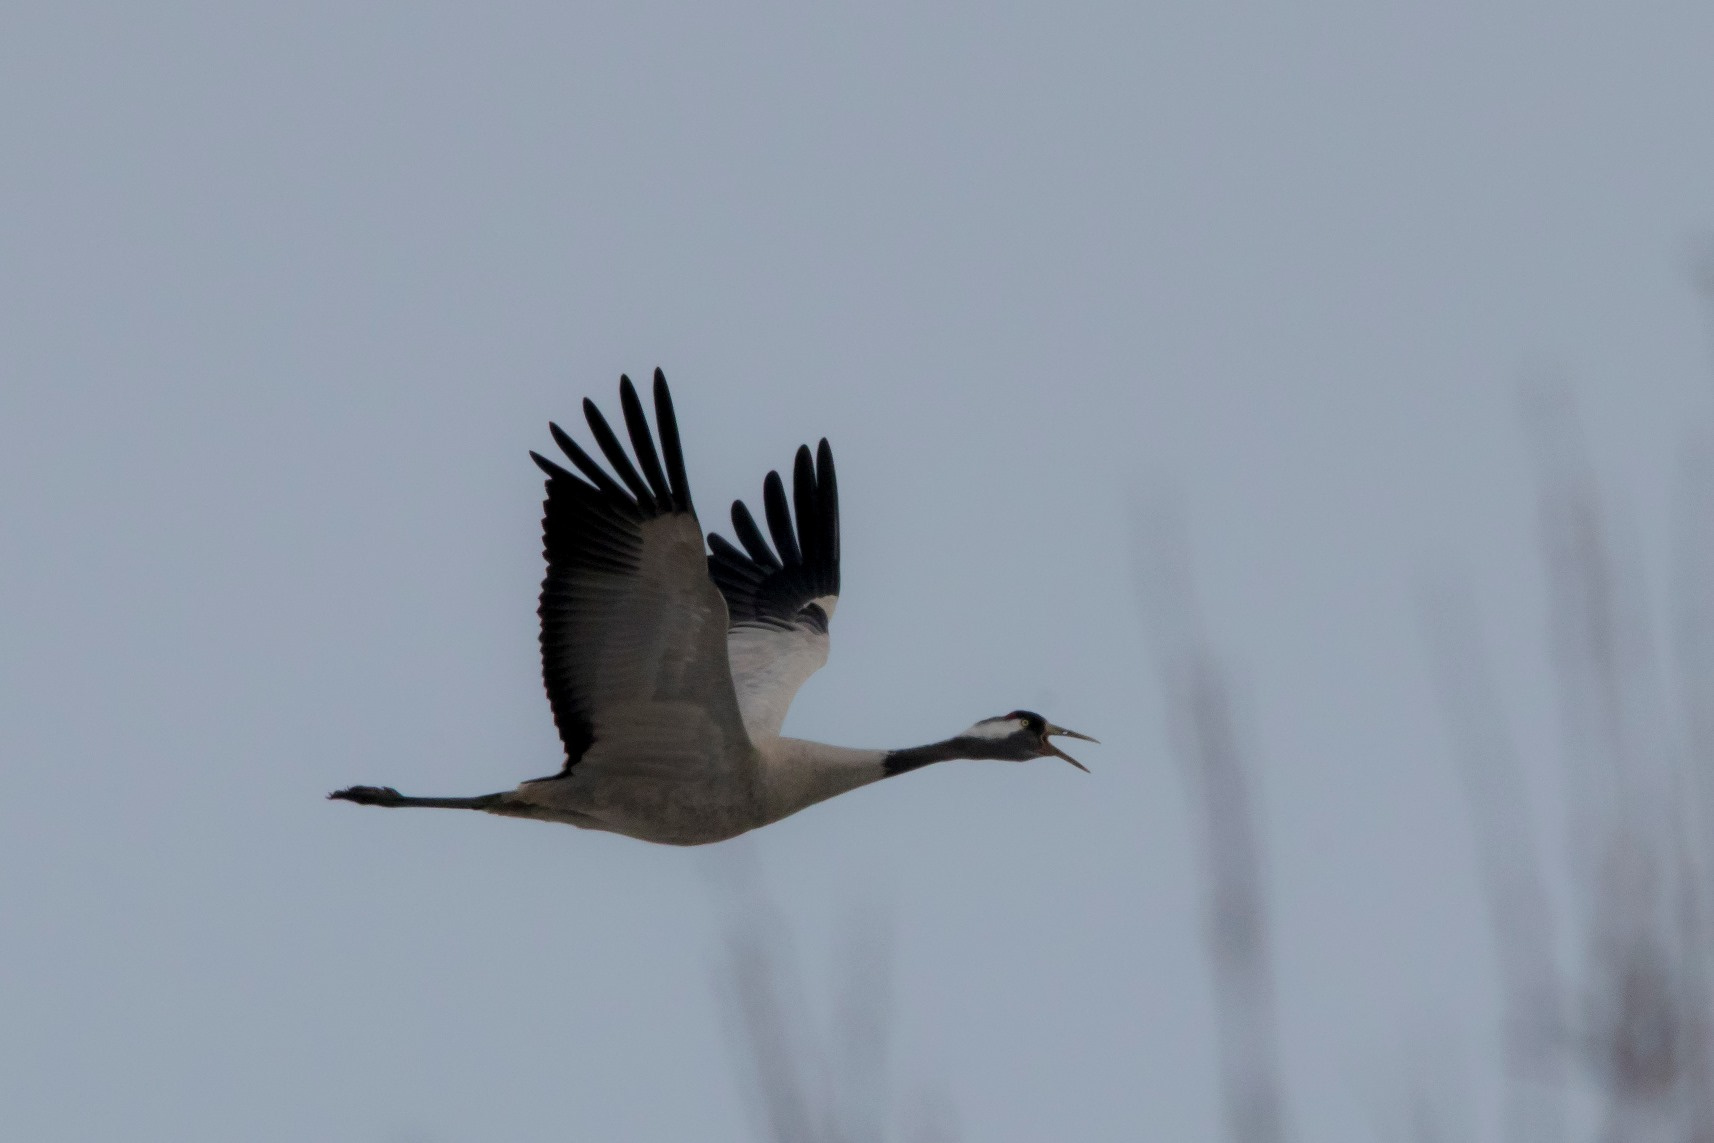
[708,440,840,740]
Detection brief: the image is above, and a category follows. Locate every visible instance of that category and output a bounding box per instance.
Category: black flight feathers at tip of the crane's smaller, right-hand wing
[708,440,840,632]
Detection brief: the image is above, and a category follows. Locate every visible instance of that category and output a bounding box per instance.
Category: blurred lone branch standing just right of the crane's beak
[1135,496,1286,1143]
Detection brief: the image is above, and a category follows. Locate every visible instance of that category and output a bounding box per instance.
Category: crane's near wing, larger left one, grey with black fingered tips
[530,370,756,790]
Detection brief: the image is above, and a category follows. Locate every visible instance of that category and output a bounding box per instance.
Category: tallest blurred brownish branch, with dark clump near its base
[1539,395,1714,1140]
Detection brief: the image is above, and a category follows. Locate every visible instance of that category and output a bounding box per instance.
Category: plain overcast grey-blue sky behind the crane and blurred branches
[0,0,1714,1143]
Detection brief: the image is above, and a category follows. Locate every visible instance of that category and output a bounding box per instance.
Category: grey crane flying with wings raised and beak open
[327,370,1094,845]
